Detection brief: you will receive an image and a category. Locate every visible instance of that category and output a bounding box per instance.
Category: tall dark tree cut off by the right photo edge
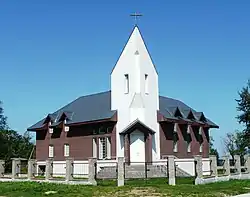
[236,80,250,148]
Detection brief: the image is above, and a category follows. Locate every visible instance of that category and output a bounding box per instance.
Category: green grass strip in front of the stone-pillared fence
[0,179,250,197]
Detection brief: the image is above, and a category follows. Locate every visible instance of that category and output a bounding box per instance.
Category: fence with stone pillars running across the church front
[0,155,250,186]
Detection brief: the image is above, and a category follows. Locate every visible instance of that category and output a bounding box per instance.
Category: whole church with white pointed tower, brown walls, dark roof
[28,25,219,166]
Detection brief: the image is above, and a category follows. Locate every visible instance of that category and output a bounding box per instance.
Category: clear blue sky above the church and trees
[0,0,250,152]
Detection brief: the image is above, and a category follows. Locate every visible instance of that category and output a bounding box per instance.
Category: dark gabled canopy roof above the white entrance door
[120,119,155,135]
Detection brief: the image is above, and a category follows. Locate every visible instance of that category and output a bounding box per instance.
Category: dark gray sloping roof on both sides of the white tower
[28,91,218,130]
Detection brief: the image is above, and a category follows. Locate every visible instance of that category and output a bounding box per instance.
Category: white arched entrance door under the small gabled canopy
[130,130,145,163]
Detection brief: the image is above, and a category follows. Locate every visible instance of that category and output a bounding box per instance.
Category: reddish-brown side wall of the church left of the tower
[36,123,116,161]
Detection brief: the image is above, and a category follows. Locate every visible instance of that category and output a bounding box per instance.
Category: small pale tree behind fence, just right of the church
[224,131,247,159]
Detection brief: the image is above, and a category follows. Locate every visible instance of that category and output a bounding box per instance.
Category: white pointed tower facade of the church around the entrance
[111,26,160,160]
